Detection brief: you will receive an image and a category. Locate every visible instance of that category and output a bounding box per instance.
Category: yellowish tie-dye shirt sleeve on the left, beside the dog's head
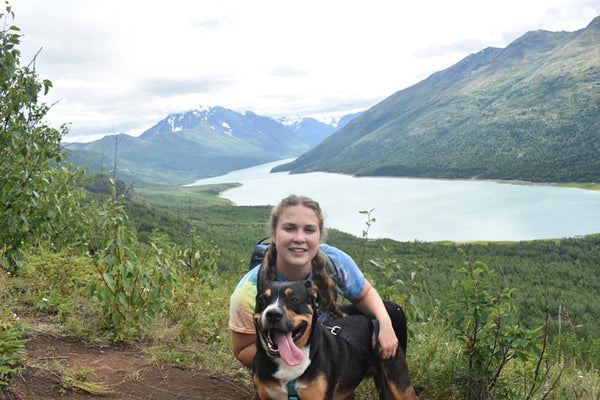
[229,266,259,334]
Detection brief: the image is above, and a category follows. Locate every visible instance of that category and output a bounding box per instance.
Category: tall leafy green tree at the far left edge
[0,2,88,269]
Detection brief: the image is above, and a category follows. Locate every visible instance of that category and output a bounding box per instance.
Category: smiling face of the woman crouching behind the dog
[271,205,321,271]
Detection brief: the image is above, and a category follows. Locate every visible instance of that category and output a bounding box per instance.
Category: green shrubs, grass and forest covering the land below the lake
[0,181,600,399]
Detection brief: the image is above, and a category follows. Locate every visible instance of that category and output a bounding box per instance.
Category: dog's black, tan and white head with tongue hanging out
[254,281,317,366]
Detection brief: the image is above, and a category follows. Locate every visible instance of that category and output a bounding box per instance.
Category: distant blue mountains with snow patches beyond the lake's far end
[65,107,356,185]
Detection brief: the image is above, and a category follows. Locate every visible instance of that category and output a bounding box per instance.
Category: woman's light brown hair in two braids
[264,194,343,318]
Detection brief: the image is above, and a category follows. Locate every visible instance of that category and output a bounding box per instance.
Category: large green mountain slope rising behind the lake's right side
[277,17,600,182]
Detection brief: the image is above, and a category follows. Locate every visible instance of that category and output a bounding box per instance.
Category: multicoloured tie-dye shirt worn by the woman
[229,244,365,334]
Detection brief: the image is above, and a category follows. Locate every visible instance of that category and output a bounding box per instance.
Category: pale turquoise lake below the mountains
[189,160,600,242]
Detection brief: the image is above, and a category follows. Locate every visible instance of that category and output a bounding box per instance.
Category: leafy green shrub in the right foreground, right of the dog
[446,252,564,399]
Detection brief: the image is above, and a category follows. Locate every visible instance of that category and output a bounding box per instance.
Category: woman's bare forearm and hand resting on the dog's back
[354,281,398,359]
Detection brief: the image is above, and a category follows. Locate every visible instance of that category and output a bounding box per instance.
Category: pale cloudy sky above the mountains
[8,0,600,141]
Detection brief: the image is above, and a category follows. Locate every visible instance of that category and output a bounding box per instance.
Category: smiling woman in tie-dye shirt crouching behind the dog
[229,195,398,367]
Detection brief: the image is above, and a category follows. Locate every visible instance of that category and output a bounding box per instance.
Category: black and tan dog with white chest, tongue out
[253,281,417,400]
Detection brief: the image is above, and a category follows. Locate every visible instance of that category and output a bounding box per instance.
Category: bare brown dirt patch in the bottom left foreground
[0,335,252,400]
